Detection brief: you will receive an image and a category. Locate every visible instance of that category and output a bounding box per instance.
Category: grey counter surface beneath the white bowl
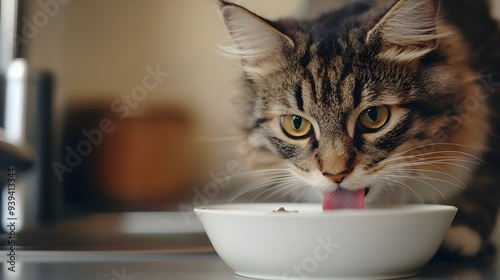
[1,244,500,280]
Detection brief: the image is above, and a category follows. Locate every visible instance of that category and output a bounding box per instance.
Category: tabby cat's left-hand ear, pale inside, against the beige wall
[219,1,294,77]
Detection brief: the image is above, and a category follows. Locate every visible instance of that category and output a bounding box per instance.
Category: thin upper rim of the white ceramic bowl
[194,202,458,219]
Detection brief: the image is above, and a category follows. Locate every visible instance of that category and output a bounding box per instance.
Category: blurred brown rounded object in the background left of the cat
[96,110,197,204]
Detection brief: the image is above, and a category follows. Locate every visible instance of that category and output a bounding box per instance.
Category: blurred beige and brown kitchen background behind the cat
[0,0,500,248]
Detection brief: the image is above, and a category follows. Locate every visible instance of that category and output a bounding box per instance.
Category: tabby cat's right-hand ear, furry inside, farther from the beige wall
[366,0,443,62]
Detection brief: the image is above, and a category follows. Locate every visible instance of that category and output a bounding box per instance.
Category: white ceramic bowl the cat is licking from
[195,203,457,279]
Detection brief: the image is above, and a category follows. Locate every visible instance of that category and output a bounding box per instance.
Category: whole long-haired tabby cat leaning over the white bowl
[216,0,500,258]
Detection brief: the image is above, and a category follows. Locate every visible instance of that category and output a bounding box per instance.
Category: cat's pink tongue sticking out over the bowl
[323,188,365,210]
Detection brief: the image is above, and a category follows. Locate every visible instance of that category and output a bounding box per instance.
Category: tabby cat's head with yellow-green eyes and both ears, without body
[218,0,488,201]
